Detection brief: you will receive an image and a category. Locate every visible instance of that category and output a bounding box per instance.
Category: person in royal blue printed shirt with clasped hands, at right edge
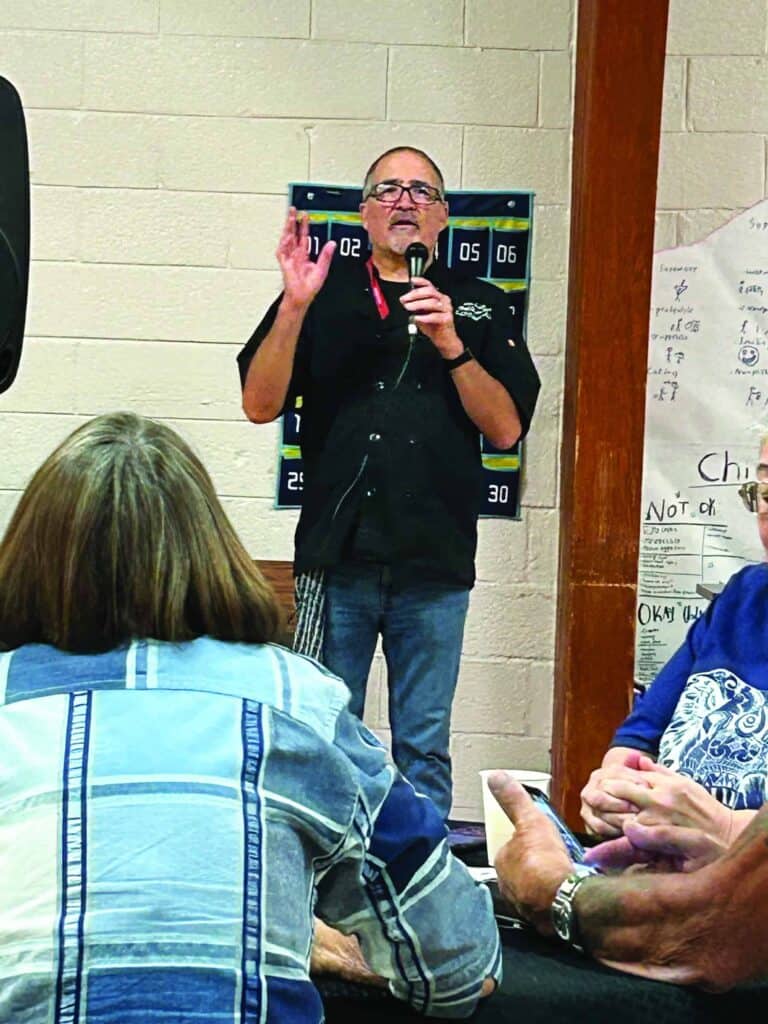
[582,437,768,846]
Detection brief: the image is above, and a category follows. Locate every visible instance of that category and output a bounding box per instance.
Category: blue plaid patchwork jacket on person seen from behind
[0,637,500,1024]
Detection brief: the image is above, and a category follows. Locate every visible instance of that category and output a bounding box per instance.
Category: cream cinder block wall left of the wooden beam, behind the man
[0,0,573,815]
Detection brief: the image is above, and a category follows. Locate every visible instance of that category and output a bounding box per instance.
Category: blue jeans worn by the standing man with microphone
[323,562,469,817]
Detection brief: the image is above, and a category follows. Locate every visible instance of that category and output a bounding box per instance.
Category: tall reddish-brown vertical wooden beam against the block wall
[553,0,668,825]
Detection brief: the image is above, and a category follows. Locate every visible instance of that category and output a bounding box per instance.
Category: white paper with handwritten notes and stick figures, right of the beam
[635,199,768,682]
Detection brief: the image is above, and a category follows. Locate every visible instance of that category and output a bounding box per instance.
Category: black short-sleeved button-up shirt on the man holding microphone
[238,260,539,587]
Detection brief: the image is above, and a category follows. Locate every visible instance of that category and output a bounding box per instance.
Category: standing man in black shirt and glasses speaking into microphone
[239,147,539,816]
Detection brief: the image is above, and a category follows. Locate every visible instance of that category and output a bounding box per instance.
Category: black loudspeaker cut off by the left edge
[0,77,30,392]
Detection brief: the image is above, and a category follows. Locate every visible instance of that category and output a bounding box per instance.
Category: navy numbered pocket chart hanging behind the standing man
[275,184,534,519]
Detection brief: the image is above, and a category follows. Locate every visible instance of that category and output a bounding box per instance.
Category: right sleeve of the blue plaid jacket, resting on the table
[315,711,501,1018]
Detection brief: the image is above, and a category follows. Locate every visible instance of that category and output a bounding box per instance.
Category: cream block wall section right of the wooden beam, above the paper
[655,0,768,249]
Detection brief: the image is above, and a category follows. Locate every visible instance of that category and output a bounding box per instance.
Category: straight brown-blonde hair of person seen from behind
[0,413,280,651]
